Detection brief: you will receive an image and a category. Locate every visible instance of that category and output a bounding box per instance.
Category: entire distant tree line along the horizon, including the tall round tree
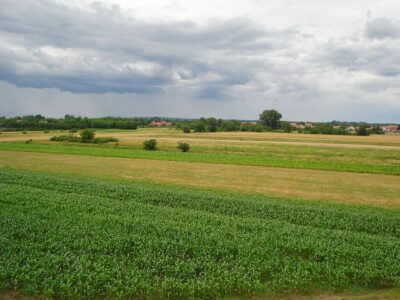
[0,109,384,135]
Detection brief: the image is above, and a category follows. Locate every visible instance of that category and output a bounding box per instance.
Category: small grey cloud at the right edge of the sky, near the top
[365,18,400,39]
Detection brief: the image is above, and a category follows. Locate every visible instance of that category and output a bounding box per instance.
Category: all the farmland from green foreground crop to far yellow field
[0,129,400,299]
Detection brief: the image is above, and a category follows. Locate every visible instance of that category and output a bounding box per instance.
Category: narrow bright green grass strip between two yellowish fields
[0,142,400,175]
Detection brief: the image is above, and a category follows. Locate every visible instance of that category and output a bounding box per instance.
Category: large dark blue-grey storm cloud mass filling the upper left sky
[0,0,297,96]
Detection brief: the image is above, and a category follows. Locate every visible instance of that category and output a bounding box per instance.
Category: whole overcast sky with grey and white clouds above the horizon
[0,0,400,123]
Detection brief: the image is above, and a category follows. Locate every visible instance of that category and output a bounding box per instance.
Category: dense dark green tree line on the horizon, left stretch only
[0,115,149,130]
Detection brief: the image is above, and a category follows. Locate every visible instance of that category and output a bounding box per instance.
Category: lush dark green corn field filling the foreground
[0,168,400,299]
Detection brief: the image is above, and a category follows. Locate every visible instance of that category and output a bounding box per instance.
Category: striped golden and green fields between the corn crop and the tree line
[0,128,400,208]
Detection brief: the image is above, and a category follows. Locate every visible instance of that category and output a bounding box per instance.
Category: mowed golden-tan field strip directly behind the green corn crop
[0,151,400,208]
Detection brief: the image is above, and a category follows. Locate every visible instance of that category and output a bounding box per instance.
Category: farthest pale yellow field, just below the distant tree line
[0,128,400,150]
